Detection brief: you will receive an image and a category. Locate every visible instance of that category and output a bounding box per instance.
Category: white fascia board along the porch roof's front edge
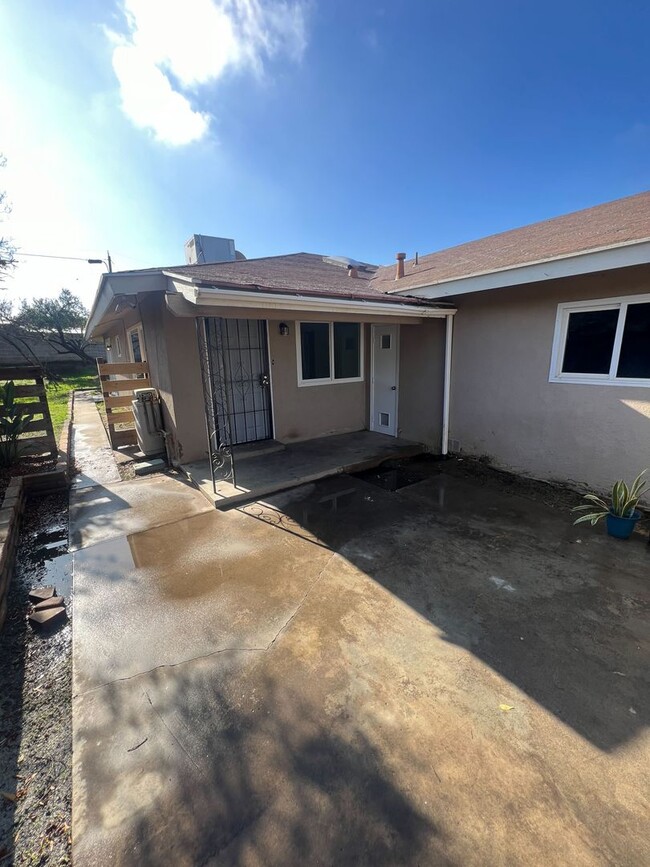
[167,280,456,319]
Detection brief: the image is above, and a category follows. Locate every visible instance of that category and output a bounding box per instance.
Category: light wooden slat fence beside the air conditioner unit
[97,361,151,449]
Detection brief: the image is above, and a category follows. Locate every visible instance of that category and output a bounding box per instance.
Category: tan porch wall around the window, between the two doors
[269,319,369,442]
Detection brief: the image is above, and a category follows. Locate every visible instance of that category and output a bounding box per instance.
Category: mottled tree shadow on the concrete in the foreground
[74,653,442,867]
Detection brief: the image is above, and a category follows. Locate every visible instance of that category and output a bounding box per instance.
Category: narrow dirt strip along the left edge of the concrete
[0,492,72,867]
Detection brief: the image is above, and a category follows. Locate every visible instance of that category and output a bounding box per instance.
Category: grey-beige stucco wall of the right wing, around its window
[450,266,650,489]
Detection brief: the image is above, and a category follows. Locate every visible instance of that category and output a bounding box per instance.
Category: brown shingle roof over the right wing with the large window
[372,191,650,292]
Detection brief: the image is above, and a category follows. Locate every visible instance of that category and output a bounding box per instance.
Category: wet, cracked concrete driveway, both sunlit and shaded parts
[73,464,650,867]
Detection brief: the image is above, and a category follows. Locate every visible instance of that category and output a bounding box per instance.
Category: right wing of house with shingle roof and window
[373,192,650,489]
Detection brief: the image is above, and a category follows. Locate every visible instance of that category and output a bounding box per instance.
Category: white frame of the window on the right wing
[548,295,650,388]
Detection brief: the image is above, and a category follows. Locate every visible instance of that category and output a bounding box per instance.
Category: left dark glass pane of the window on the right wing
[562,305,616,373]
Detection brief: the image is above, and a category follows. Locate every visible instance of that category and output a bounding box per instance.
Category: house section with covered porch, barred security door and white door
[87,244,454,502]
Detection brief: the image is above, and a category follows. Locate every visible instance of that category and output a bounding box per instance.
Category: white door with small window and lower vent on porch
[370,325,399,437]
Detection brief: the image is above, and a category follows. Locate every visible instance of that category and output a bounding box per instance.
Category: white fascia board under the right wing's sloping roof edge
[390,240,650,300]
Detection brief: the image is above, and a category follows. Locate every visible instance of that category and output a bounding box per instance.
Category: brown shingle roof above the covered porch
[164,253,440,304]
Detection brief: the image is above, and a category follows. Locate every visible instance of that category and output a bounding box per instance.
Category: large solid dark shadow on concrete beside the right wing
[244,462,650,751]
